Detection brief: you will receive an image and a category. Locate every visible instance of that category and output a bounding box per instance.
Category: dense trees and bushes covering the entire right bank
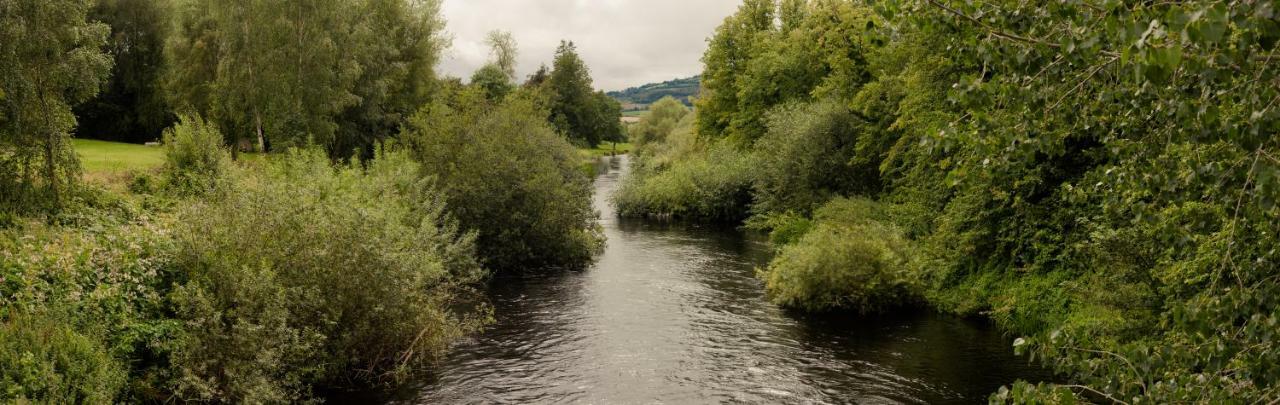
[616,0,1280,404]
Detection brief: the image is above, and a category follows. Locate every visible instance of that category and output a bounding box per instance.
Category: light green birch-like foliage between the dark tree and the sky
[166,0,447,159]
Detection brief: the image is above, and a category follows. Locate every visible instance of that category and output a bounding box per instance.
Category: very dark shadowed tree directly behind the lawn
[76,0,174,142]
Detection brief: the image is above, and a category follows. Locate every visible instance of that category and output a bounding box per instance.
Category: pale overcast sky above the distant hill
[440,0,739,91]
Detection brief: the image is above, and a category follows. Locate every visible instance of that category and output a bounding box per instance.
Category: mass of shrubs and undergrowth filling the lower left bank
[0,119,489,402]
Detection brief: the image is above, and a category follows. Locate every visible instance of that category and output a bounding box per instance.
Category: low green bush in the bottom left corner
[0,314,125,404]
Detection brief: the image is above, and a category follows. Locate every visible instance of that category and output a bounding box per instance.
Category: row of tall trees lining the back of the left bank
[0,0,622,215]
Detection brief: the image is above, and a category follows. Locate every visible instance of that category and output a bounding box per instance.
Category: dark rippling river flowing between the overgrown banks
[397,156,1048,404]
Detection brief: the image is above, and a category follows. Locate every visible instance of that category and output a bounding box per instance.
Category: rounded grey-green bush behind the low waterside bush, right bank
[754,101,882,214]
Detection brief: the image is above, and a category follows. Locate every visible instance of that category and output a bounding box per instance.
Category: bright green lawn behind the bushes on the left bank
[72,140,164,178]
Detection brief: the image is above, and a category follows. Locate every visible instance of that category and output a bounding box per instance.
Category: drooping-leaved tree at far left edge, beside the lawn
[0,0,111,211]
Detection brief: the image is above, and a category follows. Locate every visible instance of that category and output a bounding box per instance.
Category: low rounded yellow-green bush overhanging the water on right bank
[759,199,919,313]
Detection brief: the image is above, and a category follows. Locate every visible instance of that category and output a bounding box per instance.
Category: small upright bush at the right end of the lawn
[164,115,230,194]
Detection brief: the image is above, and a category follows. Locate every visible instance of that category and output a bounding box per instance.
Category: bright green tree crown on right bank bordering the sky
[696,0,874,144]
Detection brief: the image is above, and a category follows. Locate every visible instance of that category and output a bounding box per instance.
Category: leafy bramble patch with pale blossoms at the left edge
[0,210,180,402]
